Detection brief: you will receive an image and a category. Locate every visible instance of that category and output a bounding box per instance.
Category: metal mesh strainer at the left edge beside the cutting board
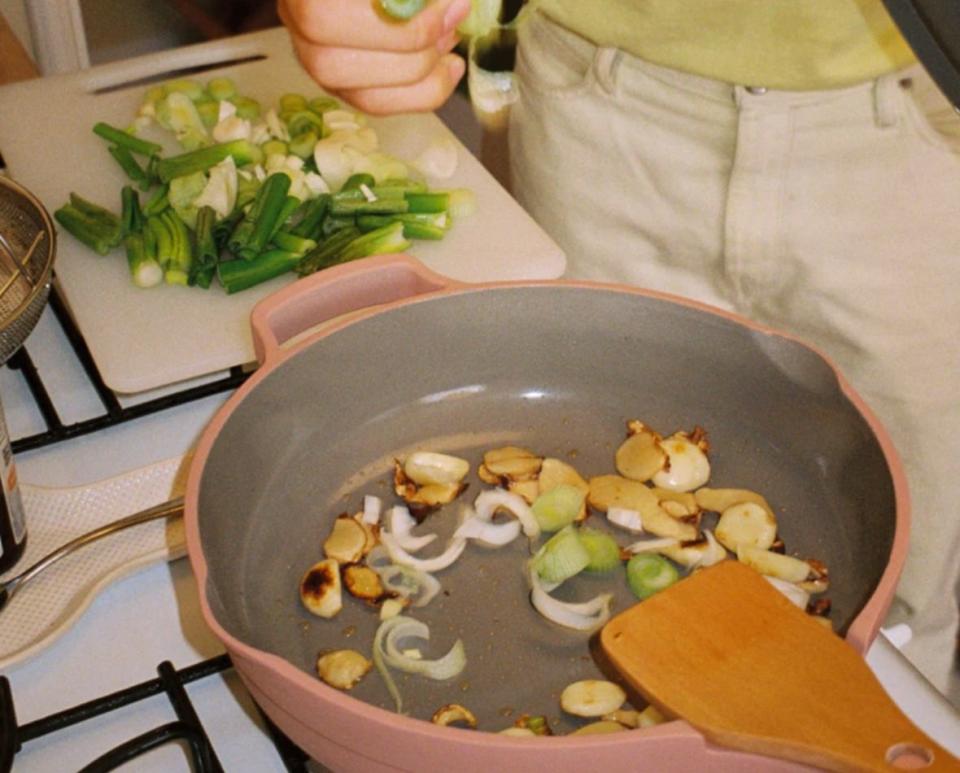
[0,175,57,364]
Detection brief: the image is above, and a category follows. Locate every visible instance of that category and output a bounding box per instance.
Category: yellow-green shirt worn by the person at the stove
[539,0,916,90]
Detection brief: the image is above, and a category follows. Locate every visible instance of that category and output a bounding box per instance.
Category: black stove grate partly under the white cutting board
[6,283,251,453]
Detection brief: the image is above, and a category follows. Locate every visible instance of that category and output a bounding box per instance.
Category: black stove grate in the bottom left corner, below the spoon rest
[0,655,309,773]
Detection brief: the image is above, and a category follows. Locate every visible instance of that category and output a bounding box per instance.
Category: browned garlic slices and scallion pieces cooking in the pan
[300,420,829,733]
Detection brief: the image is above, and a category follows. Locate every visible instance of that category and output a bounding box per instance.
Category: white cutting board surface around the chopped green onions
[0,28,565,394]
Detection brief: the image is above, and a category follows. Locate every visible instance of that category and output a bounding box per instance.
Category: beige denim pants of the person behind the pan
[509,9,960,705]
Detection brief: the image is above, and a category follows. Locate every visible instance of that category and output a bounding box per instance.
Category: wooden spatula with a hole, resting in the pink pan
[600,560,960,771]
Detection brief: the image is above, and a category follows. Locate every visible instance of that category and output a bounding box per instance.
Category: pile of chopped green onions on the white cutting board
[54,77,472,293]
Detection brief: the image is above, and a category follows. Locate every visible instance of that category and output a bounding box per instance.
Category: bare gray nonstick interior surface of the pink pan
[199,285,896,731]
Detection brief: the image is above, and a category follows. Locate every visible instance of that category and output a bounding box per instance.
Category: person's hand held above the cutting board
[277,0,470,115]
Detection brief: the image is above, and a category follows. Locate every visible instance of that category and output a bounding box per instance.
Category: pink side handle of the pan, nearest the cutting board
[250,255,463,365]
